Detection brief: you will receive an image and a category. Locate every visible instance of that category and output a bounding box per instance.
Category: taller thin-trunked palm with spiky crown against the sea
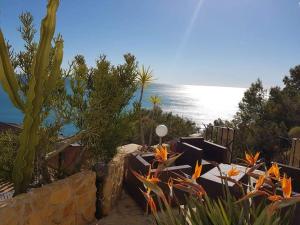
[138,66,153,145]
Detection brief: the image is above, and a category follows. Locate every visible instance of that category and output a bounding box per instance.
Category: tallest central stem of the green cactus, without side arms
[13,0,59,193]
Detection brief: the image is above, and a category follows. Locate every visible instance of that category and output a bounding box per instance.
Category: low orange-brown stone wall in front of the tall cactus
[0,171,96,225]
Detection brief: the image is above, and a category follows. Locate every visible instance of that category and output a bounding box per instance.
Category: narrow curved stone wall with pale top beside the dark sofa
[102,144,141,215]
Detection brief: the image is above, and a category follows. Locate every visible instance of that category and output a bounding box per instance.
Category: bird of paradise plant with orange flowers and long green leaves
[133,147,300,225]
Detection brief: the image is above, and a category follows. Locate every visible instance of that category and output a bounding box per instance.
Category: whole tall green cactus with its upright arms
[0,0,63,193]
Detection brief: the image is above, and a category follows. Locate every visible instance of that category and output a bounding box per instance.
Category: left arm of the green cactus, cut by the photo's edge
[0,30,24,111]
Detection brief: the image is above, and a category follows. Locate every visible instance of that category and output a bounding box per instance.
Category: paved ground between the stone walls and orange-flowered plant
[95,192,155,225]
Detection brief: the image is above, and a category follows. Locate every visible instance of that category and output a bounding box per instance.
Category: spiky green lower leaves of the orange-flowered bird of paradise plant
[155,192,292,225]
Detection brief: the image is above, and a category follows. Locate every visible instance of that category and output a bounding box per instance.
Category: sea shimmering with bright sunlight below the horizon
[0,84,246,135]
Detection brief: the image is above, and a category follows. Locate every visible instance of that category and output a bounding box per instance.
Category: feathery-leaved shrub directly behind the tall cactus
[0,9,70,190]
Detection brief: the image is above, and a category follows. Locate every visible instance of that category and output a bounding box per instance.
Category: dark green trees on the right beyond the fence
[215,66,300,161]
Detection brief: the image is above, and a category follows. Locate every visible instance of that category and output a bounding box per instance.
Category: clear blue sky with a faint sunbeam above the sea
[0,0,300,87]
